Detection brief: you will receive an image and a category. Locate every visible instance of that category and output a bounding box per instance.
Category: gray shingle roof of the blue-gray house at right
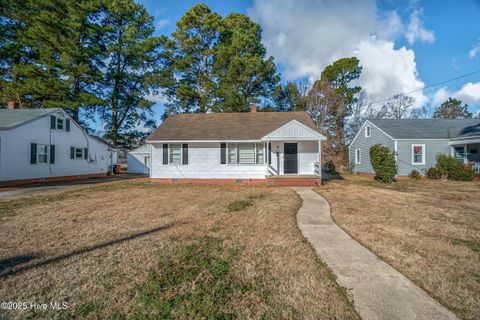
[369,119,480,139]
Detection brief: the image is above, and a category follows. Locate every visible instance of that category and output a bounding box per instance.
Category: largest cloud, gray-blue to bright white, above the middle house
[249,0,426,105]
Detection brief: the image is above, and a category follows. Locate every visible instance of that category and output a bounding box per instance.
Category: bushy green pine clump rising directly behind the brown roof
[162,4,279,113]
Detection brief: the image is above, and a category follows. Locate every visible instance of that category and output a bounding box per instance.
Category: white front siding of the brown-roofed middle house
[151,140,319,179]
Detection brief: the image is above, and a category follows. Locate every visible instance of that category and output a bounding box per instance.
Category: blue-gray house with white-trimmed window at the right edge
[349,119,480,176]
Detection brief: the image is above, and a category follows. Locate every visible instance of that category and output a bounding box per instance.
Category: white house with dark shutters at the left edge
[0,109,114,184]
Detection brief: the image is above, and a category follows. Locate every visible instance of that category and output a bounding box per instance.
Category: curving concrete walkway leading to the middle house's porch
[294,188,456,320]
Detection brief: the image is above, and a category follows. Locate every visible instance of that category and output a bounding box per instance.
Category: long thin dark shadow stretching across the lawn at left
[0,223,178,278]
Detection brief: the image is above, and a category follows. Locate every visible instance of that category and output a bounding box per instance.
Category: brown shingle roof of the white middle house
[147,111,320,141]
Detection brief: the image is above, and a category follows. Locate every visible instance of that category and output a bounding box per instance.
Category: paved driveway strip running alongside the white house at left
[0,174,148,200]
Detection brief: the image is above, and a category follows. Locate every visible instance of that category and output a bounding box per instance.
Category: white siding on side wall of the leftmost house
[0,113,107,181]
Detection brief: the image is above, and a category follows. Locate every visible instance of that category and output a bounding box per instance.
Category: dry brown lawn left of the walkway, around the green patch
[0,182,358,319]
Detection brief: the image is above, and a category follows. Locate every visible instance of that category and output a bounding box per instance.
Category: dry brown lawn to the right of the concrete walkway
[316,176,480,319]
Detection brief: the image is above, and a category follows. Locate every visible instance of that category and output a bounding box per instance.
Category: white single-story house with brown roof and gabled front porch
[146,109,325,185]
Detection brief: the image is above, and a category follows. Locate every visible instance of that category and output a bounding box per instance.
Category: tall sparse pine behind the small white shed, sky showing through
[101,0,161,145]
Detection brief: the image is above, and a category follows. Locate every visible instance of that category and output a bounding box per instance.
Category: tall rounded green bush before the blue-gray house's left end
[370,144,398,183]
